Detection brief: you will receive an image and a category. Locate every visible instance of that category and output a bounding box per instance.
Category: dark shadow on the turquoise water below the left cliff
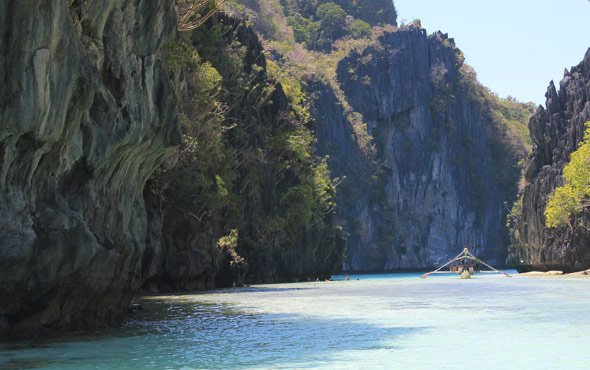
[0,301,426,369]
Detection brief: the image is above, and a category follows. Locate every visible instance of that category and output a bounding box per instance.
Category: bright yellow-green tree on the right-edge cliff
[545,122,590,231]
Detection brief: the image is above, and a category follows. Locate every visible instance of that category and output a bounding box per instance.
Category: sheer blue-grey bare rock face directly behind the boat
[312,26,507,270]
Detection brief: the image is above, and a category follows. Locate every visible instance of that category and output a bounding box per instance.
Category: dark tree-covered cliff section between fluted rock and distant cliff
[146,8,343,289]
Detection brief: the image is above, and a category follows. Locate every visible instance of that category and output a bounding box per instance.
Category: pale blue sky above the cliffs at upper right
[393,0,590,105]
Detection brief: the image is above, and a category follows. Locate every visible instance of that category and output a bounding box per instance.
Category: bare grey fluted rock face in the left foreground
[0,0,180,334]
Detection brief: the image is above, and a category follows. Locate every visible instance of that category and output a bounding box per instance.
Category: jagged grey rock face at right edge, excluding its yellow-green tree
[508,50,590,272]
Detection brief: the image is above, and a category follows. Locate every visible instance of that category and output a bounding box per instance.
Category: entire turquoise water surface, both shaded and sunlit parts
[0,273,590,369]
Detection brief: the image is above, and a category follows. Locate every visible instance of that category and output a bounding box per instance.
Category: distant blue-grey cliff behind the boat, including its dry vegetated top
[236,0,526,270]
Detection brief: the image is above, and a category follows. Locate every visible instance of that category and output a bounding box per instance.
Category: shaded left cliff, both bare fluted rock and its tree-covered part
[0,0,344,335]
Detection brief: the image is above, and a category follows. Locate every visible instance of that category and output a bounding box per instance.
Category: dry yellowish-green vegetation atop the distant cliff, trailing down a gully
[226,0,396,158]
